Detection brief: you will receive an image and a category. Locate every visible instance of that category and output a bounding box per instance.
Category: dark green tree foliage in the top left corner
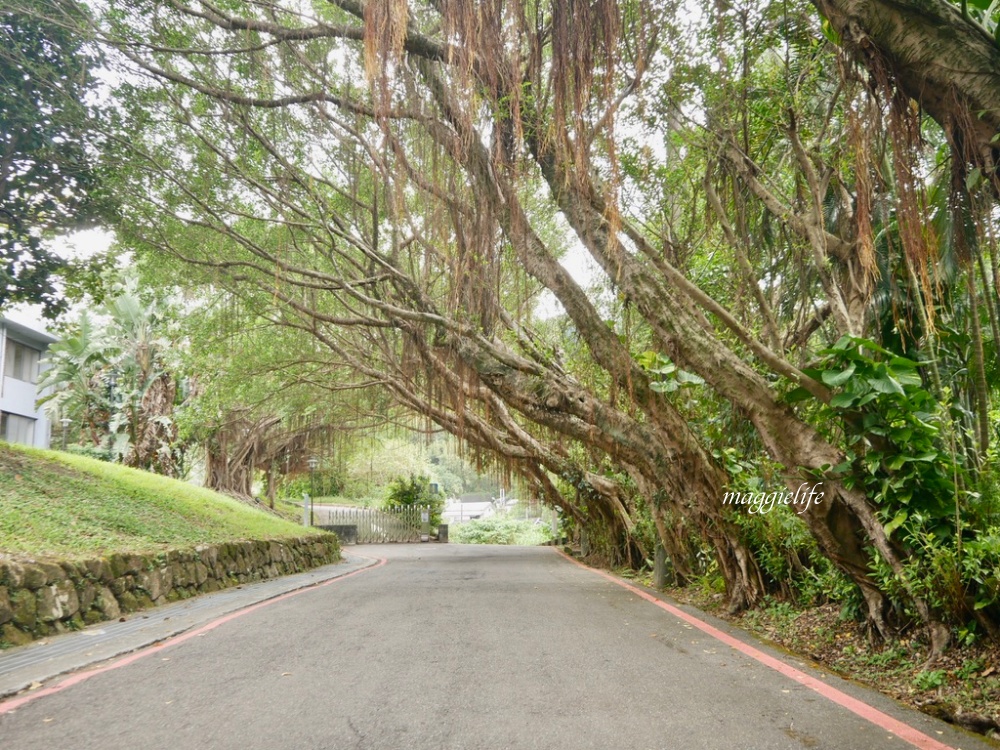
[0,0,110,315]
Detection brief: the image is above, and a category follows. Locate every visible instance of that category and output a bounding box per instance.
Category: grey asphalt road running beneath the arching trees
[0,544,989,750]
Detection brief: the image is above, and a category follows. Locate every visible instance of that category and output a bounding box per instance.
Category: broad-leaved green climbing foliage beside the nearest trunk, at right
[790,336,1000,624]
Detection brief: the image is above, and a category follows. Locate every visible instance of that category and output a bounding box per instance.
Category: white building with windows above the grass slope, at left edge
[0,317,57,448]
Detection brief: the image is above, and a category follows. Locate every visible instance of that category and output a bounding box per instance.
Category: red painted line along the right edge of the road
[560,550,954,750]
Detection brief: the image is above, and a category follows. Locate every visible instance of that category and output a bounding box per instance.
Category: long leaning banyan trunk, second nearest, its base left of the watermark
[417,60,766,611]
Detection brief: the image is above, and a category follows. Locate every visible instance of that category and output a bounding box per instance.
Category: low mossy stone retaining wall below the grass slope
[0,534,340,647]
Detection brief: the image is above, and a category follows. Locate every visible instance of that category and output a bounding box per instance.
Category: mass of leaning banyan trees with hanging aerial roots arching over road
[18,0,1000,648]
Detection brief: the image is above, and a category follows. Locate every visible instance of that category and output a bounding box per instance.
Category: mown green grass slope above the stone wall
[0,442,320,559]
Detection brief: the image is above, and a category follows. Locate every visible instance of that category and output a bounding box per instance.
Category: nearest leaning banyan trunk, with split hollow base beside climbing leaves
[536,131,947,647]
